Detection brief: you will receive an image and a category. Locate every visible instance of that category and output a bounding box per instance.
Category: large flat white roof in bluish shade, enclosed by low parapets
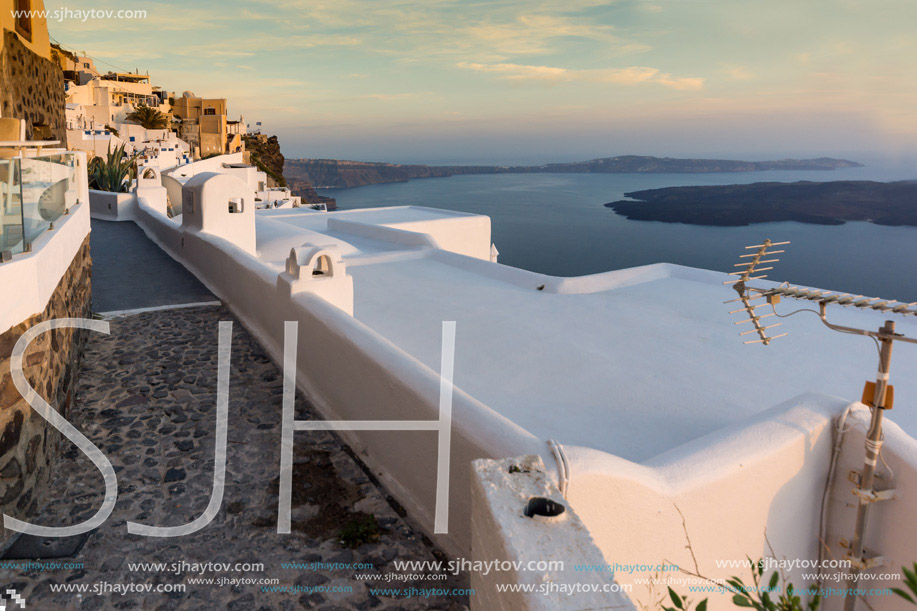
[250,208,917,462]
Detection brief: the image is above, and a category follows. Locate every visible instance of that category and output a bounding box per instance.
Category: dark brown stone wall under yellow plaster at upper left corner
[0,30,67,143]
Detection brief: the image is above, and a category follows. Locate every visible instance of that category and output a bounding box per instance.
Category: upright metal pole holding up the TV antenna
[844,320,895,611]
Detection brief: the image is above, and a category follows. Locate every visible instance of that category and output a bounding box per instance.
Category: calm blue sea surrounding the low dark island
[321,168,917,301]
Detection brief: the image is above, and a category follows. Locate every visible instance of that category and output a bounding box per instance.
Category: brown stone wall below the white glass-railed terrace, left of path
[0,235,92,549]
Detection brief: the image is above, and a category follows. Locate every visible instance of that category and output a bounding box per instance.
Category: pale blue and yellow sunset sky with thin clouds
[45,0,917,163]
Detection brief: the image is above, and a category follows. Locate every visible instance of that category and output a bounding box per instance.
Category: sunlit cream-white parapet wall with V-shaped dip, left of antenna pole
[567,395,847,609]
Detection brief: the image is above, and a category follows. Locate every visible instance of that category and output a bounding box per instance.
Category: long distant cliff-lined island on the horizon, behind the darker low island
[283,155,863,188]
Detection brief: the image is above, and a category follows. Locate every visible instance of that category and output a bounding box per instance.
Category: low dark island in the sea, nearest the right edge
[605,180,917,227]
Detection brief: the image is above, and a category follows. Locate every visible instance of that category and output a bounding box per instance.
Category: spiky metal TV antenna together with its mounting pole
[723,240,917,611]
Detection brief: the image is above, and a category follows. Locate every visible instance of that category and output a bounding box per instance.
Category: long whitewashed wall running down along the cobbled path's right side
[131,185,552,556]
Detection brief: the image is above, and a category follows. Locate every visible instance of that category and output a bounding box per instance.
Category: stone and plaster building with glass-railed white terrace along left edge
[0,0,92,550]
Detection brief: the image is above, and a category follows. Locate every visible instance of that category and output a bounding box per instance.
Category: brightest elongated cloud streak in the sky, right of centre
[456,62,704,90]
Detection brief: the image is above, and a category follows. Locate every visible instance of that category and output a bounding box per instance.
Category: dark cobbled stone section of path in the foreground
[12,307,468,611]
